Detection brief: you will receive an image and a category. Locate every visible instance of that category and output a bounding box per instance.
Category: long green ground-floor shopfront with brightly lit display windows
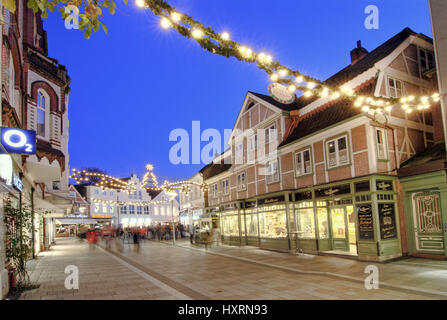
[210,175,402,261]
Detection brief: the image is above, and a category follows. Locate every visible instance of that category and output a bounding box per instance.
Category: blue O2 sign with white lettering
[0,127,36,154]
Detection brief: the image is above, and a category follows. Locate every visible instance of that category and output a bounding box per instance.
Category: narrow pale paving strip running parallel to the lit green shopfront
[171,243,447,298]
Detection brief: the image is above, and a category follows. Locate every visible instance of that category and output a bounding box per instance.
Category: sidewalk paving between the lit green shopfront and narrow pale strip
[172,241,447,299]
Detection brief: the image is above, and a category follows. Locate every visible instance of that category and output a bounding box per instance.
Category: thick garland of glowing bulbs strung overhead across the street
[135,0,440,113]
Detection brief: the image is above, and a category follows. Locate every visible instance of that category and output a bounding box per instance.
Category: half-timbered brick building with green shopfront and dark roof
[201,28,443,261]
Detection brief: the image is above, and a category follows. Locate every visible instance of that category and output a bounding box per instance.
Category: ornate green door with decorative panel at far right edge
[412,192,445,253]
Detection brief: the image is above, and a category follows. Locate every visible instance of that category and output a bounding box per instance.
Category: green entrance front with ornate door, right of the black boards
[400,170,447,258]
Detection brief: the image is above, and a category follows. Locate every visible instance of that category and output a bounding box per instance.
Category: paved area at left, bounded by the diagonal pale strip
[20,239,185,300]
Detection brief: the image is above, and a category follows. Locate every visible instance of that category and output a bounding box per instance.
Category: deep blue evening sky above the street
[44,0,432,181]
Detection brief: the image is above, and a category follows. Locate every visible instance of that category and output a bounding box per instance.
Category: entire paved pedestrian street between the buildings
[21,238,447,300]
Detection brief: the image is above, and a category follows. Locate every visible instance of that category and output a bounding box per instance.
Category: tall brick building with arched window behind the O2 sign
[0,0,70,295]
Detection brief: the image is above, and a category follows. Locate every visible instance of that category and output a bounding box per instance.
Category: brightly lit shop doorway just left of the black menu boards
[329,206,357,254]
